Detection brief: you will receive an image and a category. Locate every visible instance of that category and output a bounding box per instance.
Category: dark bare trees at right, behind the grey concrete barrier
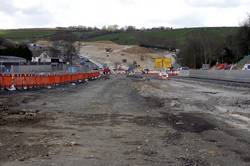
[178,16,250,69]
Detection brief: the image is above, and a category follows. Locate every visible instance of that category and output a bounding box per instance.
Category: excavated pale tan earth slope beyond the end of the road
[80,41,164,69]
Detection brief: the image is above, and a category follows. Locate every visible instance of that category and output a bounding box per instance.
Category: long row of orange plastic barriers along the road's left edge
[0,71,101,89]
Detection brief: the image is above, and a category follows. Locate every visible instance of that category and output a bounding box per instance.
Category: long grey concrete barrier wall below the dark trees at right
[179,70,250,83]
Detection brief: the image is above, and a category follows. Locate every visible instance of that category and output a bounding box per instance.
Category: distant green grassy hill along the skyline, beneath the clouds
[0,27,238,47]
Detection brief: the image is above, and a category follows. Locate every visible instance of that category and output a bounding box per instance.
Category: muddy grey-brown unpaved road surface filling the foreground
[0,76,250,166]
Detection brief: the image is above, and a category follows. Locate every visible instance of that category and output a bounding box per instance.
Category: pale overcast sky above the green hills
[0,0,250,29]
